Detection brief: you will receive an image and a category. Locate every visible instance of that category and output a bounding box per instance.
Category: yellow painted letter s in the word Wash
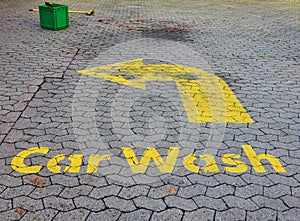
[222,154,248,173]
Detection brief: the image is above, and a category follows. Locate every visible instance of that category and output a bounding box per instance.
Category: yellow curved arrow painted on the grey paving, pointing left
[78,58,253,123]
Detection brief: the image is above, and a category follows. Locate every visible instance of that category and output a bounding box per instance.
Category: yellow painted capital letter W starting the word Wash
[122,147,180,173]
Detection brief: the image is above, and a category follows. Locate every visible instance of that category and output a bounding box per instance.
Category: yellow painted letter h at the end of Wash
[242,145,286,173]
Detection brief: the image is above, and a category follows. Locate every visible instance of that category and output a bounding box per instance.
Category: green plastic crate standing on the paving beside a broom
[39,3,69,30]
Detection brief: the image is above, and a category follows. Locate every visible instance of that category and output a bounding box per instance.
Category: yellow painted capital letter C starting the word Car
[11,147,49,173]
